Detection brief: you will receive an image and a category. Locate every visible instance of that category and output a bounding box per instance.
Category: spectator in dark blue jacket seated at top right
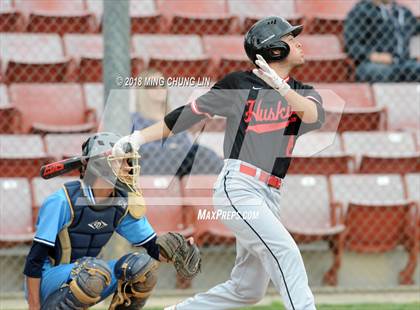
[344,0,420,82]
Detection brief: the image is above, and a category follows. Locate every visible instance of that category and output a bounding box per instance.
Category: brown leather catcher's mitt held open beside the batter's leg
[156,232,201,279]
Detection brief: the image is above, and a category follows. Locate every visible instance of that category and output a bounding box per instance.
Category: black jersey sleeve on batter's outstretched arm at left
[164,73,236,133]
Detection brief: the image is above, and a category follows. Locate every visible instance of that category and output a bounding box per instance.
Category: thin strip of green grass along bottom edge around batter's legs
[150,302,420,310]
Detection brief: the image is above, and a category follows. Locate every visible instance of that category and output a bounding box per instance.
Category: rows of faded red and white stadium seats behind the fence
[0,0,420,292]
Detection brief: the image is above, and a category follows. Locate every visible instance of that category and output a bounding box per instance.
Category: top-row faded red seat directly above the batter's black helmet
[227,0,303,33]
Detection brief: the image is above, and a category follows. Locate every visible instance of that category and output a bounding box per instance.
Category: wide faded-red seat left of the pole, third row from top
[9,83,96,133]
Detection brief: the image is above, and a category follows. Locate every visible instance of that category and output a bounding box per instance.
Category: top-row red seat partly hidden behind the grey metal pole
[86,0,167,33]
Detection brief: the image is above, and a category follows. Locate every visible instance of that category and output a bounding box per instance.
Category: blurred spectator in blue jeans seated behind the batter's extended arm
[132,69,223,176]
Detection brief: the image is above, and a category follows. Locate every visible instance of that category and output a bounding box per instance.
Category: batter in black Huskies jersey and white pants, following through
[113,17,324,310]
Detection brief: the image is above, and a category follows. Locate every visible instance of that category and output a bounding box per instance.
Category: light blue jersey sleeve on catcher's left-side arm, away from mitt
[34,189,70,247]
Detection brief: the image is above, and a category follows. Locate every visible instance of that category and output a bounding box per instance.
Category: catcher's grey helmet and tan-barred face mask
[80,132,140,193]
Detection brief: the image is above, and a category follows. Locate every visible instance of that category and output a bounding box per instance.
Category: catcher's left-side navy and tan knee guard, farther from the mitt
[42,257,111,310]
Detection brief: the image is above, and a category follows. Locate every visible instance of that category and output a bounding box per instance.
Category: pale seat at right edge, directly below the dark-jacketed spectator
[373,83,420,130]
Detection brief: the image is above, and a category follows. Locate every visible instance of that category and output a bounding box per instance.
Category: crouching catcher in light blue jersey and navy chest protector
[24,133,201,310]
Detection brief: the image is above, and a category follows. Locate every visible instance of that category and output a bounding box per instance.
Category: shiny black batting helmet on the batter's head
[244,16,303,63]
